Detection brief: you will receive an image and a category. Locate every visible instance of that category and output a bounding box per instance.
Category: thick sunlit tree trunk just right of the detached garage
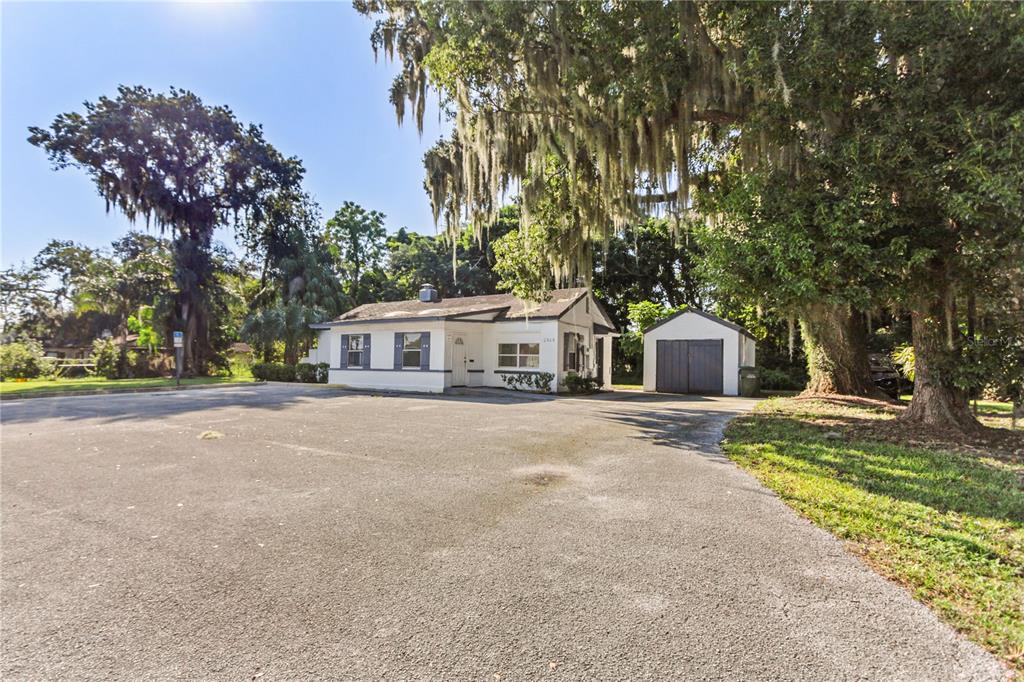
[800,303,885,397]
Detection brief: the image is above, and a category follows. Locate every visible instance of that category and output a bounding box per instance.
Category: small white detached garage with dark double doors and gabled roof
[643,309,757,395]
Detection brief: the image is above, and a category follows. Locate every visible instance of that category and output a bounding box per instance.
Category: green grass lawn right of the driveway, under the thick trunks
[723,398,1024,673]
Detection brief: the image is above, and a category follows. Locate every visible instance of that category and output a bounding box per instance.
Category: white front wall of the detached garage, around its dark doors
[643,312,755,395]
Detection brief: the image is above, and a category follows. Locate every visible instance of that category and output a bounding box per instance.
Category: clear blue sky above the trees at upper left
[0,0,441,267]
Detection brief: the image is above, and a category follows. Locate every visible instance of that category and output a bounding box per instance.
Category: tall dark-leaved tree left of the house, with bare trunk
[29,86,303,373]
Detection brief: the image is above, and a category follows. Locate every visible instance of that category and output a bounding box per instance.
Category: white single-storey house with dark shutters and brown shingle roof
[304,285,618,393]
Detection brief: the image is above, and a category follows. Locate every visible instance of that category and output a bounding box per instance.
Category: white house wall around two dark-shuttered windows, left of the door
[316,321,447,393]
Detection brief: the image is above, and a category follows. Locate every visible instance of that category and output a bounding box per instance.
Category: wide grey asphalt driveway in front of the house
[0,386,1002,680]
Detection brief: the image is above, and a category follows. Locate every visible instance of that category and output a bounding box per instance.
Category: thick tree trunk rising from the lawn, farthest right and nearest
[900,295,982,432]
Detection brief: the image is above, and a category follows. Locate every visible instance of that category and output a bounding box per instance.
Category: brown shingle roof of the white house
[328,287,587,325]
